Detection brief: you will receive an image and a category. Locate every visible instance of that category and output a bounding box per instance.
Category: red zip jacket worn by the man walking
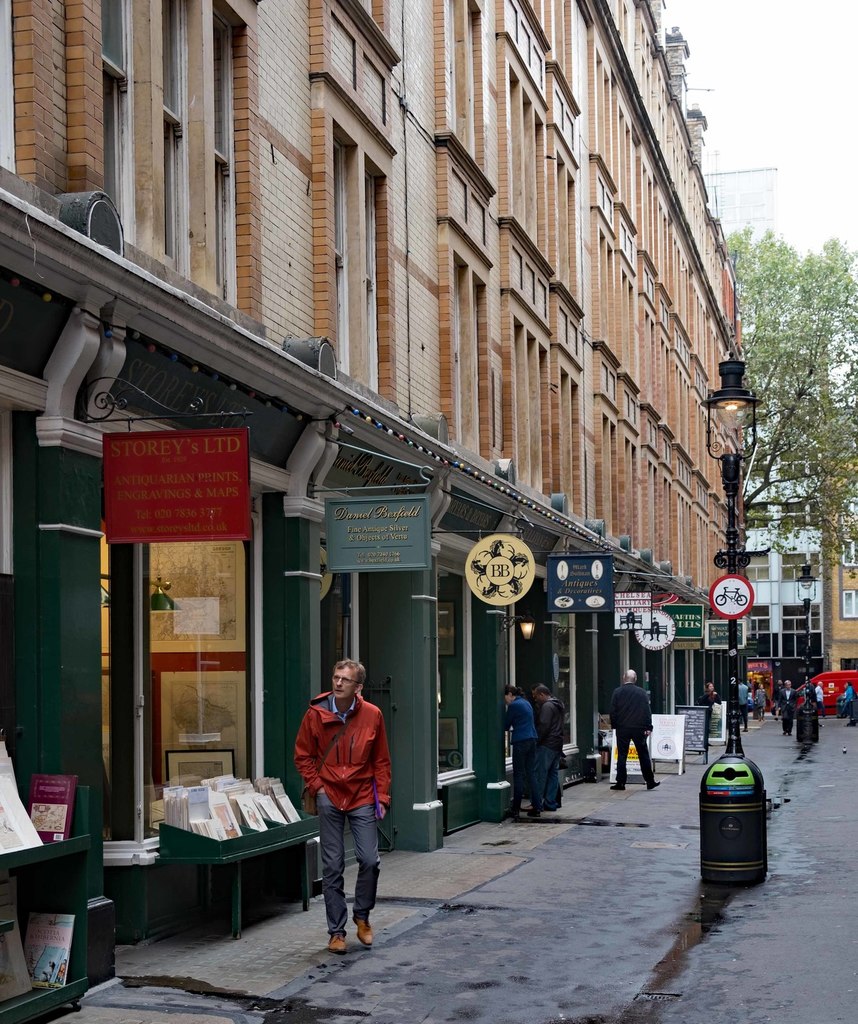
[295,692,390,811]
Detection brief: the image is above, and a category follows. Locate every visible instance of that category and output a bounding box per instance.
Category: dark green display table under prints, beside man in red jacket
[156,811,318,937]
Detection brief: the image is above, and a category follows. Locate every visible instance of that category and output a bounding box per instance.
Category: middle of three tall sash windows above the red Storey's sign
[162,0,188,273]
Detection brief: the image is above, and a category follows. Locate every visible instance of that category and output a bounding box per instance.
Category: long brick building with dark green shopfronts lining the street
[0,0,739,977]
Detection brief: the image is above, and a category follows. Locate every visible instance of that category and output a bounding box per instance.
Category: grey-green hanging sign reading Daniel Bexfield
[325,495,431,572]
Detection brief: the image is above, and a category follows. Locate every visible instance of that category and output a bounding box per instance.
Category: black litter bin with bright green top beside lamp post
[700,754,768,885]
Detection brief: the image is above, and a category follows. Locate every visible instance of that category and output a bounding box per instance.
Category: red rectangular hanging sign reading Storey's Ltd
[102,427,251,544]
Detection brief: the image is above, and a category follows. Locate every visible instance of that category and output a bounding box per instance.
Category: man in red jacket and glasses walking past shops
[295,660,390,953]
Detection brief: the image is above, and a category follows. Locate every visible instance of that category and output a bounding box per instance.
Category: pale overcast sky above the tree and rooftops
[663,0,858,251]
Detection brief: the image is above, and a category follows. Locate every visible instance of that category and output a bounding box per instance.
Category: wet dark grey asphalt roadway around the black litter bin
[69,719,858,1024]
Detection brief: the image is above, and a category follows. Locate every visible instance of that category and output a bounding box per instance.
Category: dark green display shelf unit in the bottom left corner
[0,786,90,1024]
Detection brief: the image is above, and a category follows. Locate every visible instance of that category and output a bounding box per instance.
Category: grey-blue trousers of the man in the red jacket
[316,793,381,935]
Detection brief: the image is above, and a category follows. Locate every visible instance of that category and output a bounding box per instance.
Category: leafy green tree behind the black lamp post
[729,228,858,550]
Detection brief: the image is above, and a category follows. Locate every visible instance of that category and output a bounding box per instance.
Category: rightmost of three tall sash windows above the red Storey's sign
[212,12,238,304]
